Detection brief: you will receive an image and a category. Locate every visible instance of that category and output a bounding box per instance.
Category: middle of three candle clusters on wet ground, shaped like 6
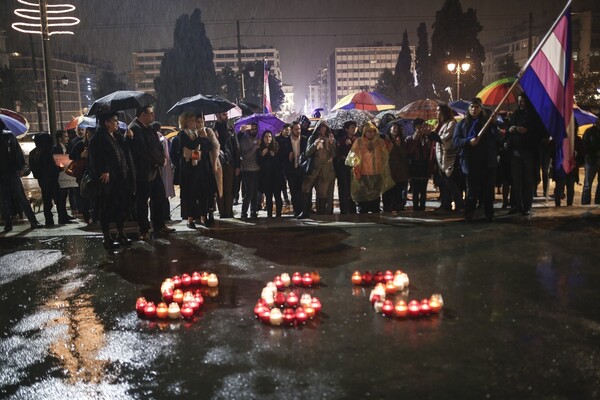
[254,272,321,326]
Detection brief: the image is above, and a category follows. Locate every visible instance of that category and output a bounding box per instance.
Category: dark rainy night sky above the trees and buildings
[0,0,576,108]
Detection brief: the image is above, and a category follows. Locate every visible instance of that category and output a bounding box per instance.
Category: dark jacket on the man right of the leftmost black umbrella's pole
[128,119,165,182]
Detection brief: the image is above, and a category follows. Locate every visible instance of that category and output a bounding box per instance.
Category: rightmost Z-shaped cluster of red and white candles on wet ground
[351,270,444,318]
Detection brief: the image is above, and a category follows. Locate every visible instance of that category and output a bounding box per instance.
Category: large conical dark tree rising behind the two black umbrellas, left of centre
[154,8,219,119]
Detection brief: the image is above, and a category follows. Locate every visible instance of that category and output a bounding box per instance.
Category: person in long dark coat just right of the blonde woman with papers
[215,112,240,218]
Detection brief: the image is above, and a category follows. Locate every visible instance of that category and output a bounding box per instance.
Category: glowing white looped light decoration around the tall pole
[12,0,80,35]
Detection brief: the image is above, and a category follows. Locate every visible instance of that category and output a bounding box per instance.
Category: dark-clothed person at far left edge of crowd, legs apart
[0,120,44,233]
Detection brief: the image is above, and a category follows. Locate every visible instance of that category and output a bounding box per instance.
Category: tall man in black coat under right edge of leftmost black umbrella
[128,105,175,240]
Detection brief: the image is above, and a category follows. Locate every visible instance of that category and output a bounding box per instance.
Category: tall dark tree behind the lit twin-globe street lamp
[431,0,485,98]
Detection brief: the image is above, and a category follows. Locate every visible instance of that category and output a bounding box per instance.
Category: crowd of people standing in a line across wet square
[0,95,600,249]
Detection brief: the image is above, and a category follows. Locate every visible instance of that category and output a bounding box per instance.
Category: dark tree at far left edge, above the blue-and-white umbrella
[0,67,35,111]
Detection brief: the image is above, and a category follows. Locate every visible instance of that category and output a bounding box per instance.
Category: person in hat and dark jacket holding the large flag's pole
[453,99,500,221]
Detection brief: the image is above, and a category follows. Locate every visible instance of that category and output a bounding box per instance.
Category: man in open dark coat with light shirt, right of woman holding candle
[279,121,308,217]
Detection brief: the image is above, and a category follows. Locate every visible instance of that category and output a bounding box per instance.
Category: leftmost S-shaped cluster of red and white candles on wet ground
[135,271,219,321]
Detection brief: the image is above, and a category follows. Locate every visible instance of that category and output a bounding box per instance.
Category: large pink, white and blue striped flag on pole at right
[520,1,576,173]
